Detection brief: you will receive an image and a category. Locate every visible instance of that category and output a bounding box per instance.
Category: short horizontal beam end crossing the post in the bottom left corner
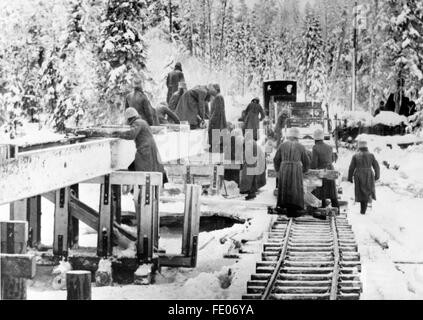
[0,253,36,279]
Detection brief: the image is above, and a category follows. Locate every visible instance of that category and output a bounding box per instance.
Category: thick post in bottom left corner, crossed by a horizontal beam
[0,221,28,300]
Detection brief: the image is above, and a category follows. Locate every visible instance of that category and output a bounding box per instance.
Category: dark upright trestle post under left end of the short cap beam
[97,175,113,257]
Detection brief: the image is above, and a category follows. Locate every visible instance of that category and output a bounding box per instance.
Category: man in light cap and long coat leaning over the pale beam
[117,108,167,183]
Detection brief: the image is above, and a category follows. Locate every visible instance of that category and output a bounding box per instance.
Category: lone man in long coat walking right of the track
[348,140,380,214]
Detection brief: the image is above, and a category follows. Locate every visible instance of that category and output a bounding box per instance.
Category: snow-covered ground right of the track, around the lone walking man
[338,136,423,299]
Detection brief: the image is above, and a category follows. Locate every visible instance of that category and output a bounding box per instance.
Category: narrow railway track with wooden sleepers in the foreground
[242,217,362,300]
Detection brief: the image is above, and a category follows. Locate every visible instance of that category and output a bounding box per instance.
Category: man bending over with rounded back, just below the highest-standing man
[176,86,211,129]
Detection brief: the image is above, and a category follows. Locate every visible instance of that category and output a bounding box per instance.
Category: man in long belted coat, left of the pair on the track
[273,127,310,217]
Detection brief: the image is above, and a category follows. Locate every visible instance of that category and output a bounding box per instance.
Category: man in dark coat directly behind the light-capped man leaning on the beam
[125,79,158,126]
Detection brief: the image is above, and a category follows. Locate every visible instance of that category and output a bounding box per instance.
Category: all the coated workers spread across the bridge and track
[119,63,380,216]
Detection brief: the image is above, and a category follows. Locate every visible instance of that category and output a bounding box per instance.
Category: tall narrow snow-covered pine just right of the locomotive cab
[297,6,326,100]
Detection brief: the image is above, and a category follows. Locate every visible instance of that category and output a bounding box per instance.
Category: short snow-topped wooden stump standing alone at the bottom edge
[66,270,91,300]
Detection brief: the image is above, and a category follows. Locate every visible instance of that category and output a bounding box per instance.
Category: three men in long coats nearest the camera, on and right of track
[273,128,380,216]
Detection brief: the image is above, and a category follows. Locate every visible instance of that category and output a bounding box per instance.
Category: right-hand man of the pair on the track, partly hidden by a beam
[311,128,339,208]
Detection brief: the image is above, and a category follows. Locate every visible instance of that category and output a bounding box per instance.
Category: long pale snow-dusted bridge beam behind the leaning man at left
[0,130,207,205]
